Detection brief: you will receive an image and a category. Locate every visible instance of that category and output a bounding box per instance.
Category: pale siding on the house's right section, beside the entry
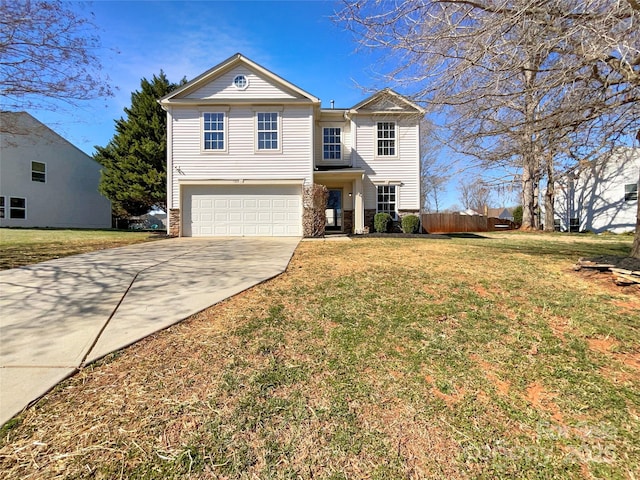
[354,116,420,210]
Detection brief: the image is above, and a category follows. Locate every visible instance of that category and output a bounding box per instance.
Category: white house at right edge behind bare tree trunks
[555,148,640,233]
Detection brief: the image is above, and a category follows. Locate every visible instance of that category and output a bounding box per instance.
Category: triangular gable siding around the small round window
[184,67,301,100]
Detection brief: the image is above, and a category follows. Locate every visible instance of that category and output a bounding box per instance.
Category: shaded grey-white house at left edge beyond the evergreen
[0,112,111,228]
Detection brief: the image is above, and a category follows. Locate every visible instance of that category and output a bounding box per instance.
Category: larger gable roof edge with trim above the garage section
[158,53,320,105]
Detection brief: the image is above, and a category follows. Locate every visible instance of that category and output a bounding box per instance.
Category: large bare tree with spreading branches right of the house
[338,0,640,246]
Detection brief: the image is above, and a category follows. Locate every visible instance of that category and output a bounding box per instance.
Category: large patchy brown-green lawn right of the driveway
[0,233,640,479]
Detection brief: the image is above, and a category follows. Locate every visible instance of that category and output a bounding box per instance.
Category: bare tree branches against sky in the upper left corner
[0,0,113,131]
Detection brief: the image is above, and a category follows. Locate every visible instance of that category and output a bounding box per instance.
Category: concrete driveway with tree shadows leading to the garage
[0,237,299,425]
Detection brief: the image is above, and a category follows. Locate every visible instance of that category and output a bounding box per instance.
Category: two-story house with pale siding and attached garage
[160,54,424,236]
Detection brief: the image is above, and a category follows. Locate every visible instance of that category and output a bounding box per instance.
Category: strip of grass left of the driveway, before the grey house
[0,228,163,270]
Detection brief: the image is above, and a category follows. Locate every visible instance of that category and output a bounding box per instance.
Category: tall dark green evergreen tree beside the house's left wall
[93,71,186,217]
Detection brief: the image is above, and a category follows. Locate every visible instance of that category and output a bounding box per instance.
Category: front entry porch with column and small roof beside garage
[313,168,365,234]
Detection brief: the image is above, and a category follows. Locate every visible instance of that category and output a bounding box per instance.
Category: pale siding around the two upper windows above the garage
[171,106,313,208]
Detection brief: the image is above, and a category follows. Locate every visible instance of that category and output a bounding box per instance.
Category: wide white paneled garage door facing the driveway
[182,185,302,237]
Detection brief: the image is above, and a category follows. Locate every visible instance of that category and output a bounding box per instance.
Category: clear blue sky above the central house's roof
[23,0,496,208]
